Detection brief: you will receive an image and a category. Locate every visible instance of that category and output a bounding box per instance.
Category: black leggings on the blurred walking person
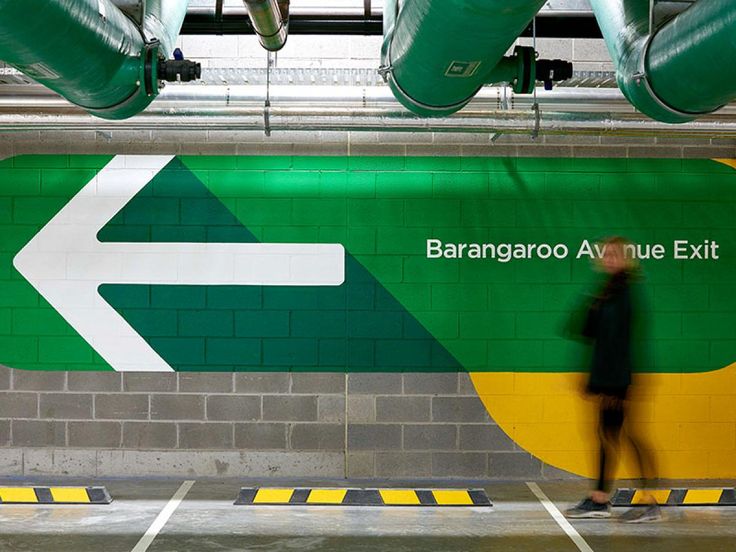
[596,394,656,492]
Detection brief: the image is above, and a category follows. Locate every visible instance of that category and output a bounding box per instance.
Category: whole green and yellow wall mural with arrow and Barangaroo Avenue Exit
[0,156,736,478]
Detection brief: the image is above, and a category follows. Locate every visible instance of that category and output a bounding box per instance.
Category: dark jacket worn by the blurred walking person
[582,272,634,395]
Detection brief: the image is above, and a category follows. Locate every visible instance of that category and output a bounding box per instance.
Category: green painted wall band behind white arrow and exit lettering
[0,156,736,372]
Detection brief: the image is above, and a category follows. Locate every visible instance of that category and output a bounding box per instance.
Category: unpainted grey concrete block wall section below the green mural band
[0,367,559,479]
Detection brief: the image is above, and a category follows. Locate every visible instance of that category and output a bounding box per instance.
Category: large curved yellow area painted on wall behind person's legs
[470,362,736,479]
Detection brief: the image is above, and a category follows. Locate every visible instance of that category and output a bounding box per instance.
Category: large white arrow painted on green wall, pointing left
[13,155,345,372]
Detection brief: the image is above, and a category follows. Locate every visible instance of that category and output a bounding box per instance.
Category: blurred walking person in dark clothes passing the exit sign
[565,237,661,523]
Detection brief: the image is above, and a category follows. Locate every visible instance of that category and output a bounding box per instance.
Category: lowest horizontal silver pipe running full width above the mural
[0,108,736,138]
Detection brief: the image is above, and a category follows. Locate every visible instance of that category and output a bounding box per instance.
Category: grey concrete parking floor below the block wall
[0,479,736,552]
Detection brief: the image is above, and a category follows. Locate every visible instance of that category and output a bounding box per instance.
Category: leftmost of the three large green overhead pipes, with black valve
[0,0,193,119]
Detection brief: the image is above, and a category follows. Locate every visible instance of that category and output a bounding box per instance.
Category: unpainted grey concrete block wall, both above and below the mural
[0,32,736,479]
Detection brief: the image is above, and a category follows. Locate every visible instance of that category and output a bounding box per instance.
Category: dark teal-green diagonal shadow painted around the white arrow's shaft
[98,160,462,372]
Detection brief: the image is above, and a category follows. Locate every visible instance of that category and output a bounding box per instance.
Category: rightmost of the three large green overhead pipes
[591,0,736,123]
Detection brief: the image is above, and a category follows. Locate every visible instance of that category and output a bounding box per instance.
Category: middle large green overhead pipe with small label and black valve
[381,0,545,116]
